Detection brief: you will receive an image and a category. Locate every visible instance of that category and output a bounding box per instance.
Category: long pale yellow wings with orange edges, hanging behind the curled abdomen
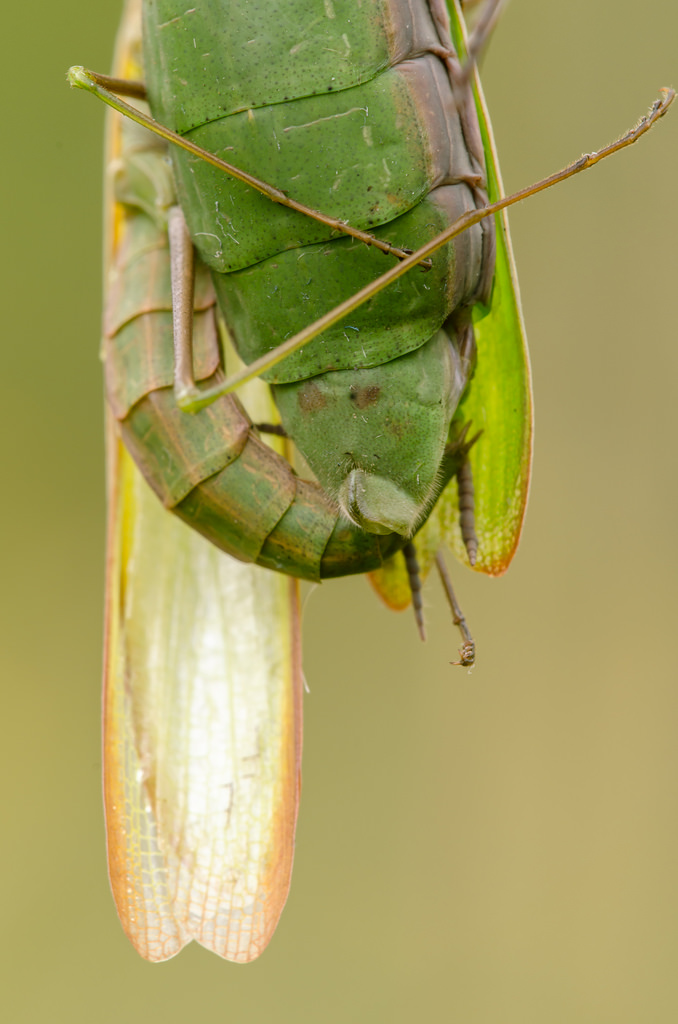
[103,0,301,963]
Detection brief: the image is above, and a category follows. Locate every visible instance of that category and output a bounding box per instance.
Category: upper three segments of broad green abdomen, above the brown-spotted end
[144,0,493,383]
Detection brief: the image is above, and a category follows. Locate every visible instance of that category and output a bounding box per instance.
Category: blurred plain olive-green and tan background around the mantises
[0,0,678,1024]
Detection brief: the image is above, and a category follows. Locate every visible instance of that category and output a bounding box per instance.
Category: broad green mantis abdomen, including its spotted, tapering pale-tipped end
[140,0,494,537]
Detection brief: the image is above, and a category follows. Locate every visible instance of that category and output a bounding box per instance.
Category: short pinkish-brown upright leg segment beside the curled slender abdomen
[167,206,196,399]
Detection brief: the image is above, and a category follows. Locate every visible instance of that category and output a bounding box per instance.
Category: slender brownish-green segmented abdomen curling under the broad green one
[103,126,405,580]
